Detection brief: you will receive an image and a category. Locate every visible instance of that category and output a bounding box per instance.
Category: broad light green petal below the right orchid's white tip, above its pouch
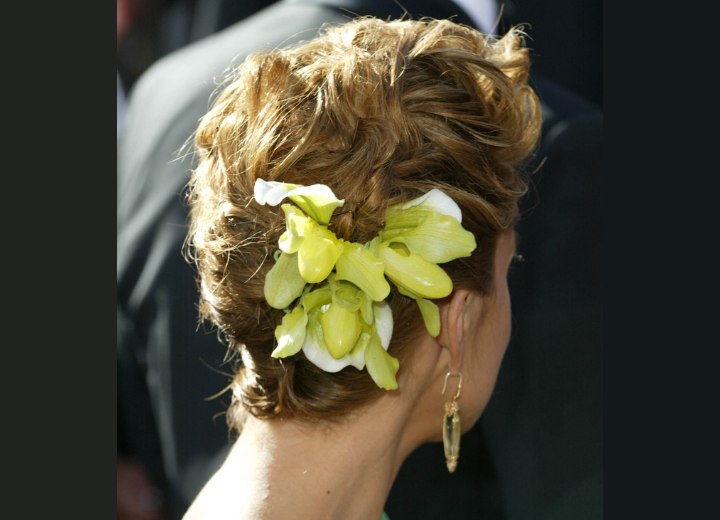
[380,212,476,264]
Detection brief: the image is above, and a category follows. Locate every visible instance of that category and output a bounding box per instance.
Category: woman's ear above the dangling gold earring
[437,289,473,374]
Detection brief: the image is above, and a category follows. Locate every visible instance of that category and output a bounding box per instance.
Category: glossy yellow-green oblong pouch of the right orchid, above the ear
[378,244,452,299]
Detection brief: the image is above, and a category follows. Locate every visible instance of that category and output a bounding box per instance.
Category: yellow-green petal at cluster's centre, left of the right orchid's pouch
[336,242,390,302]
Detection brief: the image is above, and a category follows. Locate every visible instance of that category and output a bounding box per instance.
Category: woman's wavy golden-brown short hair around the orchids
[188,18,540,428]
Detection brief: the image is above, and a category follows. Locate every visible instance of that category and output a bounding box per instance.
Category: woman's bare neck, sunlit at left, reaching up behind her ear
[197,335,449,520]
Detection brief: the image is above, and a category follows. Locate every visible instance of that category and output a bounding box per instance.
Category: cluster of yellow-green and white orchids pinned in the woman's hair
[254,179,476,390]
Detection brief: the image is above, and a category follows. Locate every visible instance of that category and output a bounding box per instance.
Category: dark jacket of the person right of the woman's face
[480,99,603,520]
